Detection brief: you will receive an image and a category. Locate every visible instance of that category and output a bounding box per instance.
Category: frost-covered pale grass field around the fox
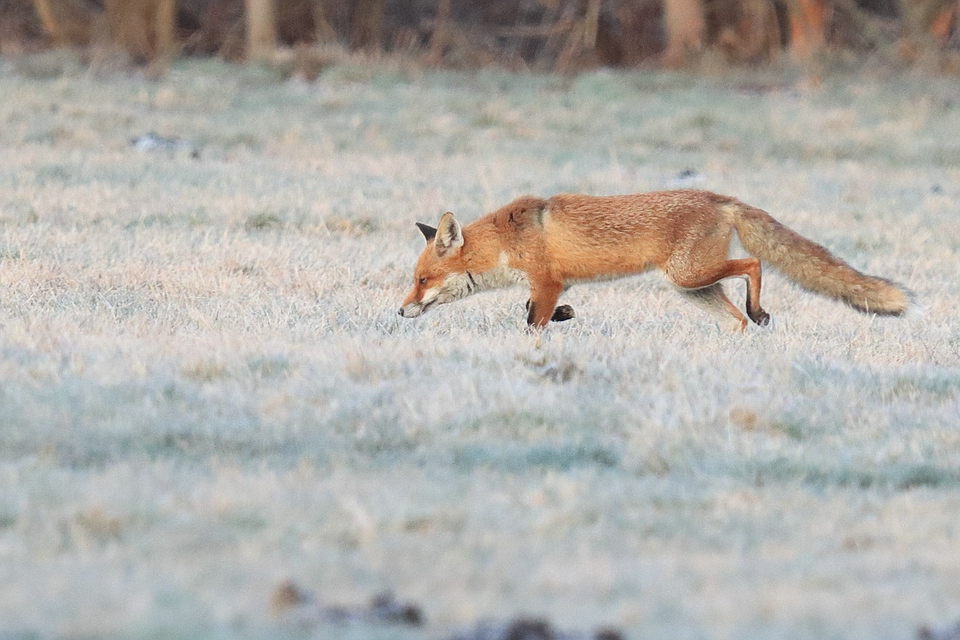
[0,52,960,639]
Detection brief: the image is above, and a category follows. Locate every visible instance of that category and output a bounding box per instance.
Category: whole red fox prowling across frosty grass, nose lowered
[400,190,912,331]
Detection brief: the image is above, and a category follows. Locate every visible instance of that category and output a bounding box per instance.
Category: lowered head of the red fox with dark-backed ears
[400,211,477,318]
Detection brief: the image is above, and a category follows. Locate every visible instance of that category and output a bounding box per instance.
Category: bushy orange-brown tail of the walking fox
[724,202,912,316]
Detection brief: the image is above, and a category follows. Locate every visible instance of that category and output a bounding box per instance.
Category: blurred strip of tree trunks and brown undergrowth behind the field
[0,0,960,78]
